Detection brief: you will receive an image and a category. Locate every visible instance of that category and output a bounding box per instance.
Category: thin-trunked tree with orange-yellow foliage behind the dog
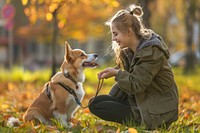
[22,0,119,75]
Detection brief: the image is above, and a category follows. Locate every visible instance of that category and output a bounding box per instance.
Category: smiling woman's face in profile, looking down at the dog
[110,24,131,49]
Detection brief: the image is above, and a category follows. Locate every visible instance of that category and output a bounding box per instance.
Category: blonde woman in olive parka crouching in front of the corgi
[89,5,178,129]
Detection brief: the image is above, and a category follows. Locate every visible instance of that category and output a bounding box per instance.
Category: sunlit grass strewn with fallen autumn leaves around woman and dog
[0,67,200,133]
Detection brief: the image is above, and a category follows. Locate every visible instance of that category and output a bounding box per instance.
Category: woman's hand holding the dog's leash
[98,68,119,79]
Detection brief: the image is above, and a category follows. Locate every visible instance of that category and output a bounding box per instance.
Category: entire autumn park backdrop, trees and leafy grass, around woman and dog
[0,0,200,133]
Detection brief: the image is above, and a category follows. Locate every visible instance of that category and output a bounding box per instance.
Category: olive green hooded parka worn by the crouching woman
[110,33,178,129]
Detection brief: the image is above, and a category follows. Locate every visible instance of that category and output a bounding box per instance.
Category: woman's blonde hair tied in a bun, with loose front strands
[106,4,151,67]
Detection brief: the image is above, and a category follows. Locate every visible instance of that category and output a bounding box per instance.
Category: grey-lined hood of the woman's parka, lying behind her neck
[137,31,170,58]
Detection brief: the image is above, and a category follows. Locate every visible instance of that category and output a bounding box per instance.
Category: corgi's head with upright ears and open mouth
[61,42,98,76]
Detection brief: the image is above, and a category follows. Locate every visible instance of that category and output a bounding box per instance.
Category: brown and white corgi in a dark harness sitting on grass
[23,42,97,126]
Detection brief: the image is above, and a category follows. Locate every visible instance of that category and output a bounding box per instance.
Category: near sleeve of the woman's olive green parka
[115,47,164,94]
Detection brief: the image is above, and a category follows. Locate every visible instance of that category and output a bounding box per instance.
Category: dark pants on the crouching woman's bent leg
[89,95,133,124]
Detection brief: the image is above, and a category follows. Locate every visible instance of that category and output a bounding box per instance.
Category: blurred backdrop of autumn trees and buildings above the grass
[0,0,200,74]
